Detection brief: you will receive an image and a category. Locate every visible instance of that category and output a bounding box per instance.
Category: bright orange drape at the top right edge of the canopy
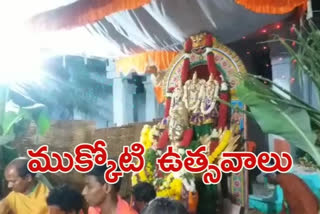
[235,0,308,14]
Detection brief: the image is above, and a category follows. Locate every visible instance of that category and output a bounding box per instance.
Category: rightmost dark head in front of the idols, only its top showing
[142,198,188,214]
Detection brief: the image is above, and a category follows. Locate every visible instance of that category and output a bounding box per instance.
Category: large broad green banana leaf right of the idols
[236,76,320,164]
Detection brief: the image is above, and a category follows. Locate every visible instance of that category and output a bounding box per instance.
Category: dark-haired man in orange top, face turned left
[82,160,137,214]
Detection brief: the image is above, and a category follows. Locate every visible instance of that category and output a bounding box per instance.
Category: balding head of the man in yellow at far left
[5,157,36,193]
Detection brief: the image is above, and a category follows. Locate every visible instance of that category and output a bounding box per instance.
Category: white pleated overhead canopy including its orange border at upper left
[27,0,300,58]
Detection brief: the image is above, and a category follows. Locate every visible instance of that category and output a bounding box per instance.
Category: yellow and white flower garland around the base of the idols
[132,125,233,200]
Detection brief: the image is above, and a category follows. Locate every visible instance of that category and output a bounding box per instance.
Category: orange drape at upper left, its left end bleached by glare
[30,0,151,30]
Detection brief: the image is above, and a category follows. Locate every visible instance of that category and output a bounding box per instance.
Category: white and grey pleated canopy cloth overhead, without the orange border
[23,0,292,59]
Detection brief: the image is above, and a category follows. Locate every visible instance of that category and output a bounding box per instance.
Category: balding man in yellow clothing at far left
[0,157,49,214]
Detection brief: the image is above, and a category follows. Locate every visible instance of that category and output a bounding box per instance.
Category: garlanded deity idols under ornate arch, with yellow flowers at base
[133,33,249,214]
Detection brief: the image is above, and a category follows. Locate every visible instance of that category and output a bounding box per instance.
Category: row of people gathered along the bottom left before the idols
[0,158,188,214]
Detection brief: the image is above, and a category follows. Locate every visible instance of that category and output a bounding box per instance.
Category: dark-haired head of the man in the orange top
[82,159,121,206]
